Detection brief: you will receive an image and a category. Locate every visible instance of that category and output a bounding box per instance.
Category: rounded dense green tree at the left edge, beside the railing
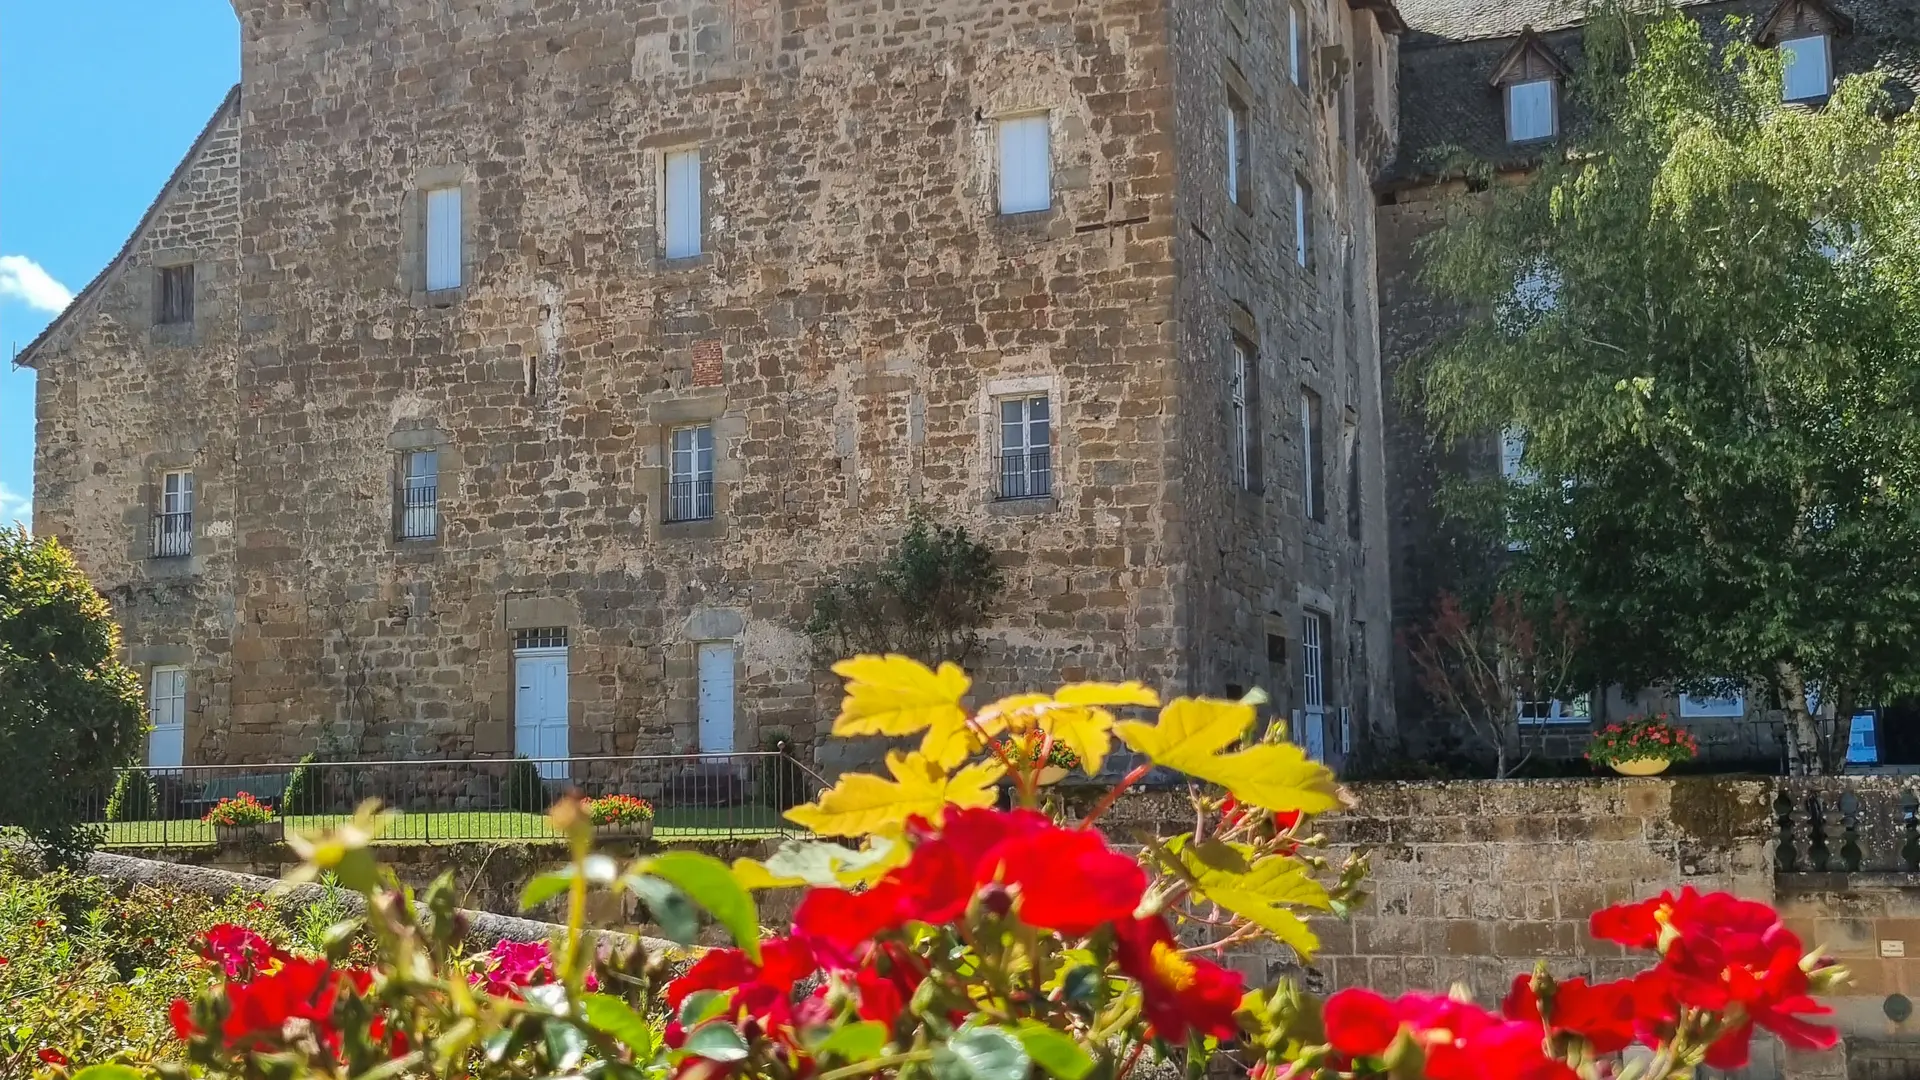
[0,528,146,861]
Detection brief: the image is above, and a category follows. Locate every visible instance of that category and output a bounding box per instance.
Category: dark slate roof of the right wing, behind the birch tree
[1380,0,1920,188]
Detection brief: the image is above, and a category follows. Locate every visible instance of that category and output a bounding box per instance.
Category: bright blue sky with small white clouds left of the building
[0,0,240,521]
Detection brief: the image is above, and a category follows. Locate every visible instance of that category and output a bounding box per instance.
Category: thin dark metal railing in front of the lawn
[83,751,824,847]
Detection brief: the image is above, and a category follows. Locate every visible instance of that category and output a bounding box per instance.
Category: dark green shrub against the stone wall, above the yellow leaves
[806,511,1006,665]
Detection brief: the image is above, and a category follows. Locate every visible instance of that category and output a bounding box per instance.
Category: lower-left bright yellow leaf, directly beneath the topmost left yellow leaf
[787,751,1004,836]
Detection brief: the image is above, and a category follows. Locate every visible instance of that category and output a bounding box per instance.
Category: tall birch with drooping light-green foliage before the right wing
[1421,10,1920,771]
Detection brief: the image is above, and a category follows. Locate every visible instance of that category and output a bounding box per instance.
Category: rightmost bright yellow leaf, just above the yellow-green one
[1114,698,1340,813]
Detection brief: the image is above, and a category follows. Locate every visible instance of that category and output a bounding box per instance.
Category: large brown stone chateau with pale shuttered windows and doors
[21,0,1920,767]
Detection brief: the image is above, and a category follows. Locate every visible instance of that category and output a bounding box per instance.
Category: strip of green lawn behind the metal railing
[106,805,801,847]
